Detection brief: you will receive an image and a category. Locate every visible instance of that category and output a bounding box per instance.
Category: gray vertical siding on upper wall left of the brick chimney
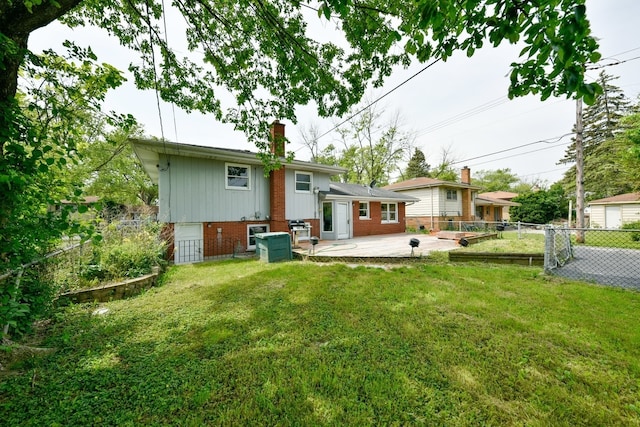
[159,156,270,222]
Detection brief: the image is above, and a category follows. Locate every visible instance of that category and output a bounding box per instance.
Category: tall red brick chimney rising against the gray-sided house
[269,120,289,231]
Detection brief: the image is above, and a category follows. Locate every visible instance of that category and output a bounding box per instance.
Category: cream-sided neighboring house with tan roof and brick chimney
[384,166,480,230]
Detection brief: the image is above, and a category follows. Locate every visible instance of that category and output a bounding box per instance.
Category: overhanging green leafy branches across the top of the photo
[0,0,600,154]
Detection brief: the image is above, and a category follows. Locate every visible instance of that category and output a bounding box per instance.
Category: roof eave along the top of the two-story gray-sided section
[129,138,346,184]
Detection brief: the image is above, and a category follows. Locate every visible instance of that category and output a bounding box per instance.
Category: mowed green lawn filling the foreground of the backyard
[0,260,640,426]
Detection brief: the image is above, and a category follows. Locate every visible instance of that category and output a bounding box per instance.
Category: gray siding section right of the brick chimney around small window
[285,167,330,219]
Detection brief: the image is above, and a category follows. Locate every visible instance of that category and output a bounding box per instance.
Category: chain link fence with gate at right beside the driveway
[544,227,640,290]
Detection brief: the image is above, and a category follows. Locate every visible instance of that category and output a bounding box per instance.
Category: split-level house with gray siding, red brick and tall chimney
[131,121,416,262]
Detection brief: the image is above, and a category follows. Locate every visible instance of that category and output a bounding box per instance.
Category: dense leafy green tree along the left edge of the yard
[0,44,127,334]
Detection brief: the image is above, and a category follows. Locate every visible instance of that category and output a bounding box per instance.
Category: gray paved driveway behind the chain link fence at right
[553,246,640,290]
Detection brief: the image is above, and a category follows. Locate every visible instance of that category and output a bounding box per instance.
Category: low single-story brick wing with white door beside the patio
[320,182,418,240]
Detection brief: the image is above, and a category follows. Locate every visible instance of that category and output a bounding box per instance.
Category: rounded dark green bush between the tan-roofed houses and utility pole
[509,184,569,224]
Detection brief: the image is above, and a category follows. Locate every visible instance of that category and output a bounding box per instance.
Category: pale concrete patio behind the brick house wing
[293,233,459,258]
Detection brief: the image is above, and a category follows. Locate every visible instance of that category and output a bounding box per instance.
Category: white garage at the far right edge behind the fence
[588,193,640,228]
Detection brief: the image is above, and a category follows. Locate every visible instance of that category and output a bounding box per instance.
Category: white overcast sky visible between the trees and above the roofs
[29,0,640,183]
